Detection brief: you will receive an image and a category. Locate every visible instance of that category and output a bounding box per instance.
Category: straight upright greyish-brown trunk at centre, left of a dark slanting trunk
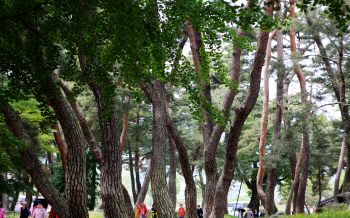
[151,80,176,218]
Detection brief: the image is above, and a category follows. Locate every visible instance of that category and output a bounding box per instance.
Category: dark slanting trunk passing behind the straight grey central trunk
[140,83,197,218]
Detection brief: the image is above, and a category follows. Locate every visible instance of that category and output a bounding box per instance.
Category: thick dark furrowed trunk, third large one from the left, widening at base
[86,78,130,218]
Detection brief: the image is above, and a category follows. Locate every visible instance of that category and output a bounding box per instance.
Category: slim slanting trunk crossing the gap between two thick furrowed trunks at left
[58,79,102,165]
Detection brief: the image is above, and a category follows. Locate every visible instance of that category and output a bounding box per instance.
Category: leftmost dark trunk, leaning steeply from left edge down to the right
[0,99,69,218]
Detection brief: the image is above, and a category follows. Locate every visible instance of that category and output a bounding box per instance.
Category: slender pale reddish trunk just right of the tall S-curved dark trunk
[256,30,277,215]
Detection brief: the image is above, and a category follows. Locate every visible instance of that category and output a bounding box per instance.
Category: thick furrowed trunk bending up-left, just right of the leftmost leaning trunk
[45,74,89,218]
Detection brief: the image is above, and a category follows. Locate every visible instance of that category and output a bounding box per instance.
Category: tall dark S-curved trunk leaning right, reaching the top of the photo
[211,2,272,215]
